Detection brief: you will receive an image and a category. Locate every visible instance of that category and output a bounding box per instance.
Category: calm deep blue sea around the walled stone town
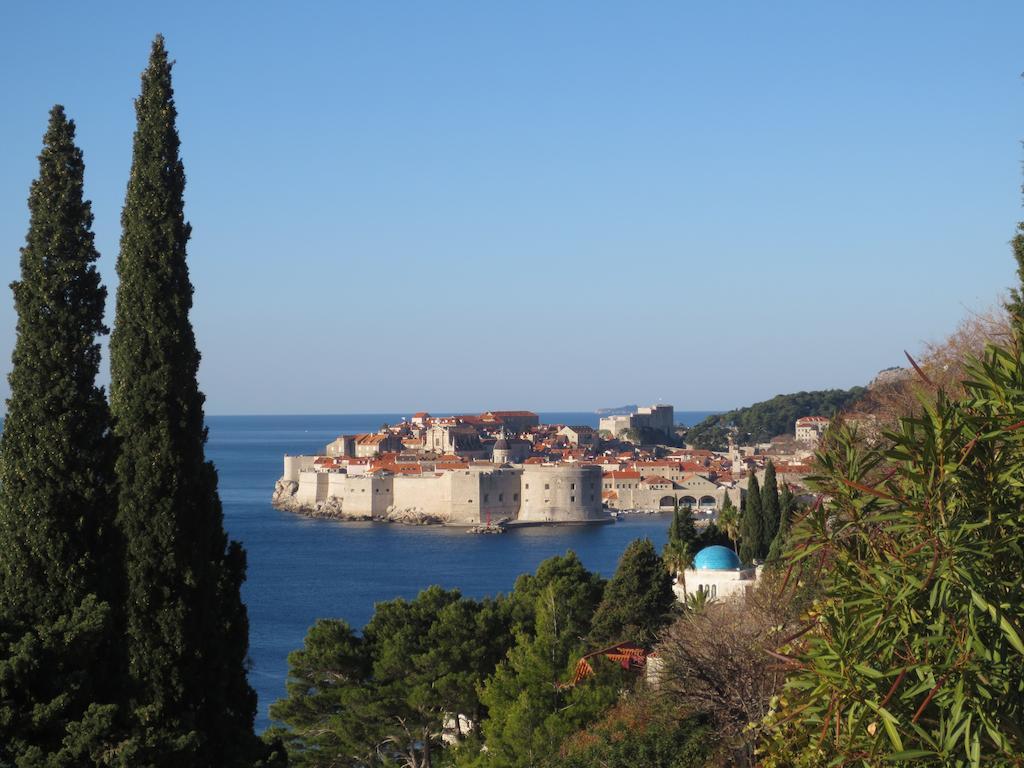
[207,412,709,731]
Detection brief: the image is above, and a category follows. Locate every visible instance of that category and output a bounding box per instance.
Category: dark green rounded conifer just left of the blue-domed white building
[590,539,675,646]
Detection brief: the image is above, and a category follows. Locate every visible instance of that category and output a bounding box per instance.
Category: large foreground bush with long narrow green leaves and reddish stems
[769,335,1024,766]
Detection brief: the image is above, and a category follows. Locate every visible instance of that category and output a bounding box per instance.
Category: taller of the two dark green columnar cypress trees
[111,36,257,768]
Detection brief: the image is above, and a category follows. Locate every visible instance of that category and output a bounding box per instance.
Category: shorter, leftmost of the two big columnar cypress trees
[0,105,118,766]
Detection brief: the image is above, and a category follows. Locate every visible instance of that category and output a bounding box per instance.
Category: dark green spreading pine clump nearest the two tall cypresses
[266,587,512,768]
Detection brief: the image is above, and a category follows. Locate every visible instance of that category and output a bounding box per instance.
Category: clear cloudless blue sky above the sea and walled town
[0,0,1024,414]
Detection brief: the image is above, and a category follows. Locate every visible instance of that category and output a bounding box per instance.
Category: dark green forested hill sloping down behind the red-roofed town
[686,387,867,451]
